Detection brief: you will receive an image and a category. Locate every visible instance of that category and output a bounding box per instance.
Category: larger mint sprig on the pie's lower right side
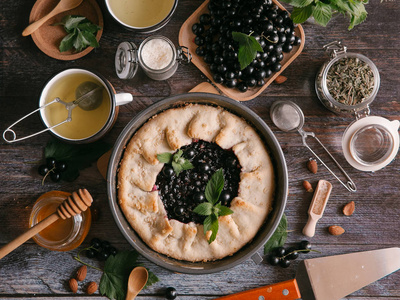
[193,169,233,244]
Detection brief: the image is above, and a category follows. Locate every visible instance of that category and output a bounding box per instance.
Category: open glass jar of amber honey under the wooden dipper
[29,191,92,251]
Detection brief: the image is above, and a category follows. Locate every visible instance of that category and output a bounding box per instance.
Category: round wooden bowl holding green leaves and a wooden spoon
[29,0,104,60]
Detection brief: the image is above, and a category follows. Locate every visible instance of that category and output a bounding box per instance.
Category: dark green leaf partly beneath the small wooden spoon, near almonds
[99,251,158,300]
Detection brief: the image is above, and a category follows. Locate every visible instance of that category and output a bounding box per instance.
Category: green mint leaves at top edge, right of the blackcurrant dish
[282,0,368,30]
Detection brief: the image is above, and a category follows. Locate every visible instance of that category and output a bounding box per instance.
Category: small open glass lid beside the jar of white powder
[115,42,139,79]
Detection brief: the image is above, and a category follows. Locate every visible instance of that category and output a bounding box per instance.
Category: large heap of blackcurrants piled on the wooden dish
[192,0,301,92]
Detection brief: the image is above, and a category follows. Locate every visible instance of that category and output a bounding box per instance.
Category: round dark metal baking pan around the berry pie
[107,93,288,274]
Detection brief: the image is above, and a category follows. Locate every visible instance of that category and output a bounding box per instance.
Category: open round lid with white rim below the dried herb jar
[342,116,400,172]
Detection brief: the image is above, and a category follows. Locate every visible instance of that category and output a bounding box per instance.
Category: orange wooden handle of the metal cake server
[212,279,301,300]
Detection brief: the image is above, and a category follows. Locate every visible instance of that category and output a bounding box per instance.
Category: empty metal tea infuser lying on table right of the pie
[270,100,357,192]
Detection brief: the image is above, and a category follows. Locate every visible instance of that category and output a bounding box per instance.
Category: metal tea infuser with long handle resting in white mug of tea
[3,82,104,143]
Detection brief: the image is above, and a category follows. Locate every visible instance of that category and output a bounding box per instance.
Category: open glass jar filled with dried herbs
[315,42,380,114]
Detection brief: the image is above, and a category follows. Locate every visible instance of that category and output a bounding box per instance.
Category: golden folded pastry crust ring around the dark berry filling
[118,104,275,262]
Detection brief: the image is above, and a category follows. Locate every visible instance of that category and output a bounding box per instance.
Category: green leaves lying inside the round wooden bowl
[54,15,101,52]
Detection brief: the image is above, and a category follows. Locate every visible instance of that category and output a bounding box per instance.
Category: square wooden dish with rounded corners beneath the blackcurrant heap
[179,0,305,101]
